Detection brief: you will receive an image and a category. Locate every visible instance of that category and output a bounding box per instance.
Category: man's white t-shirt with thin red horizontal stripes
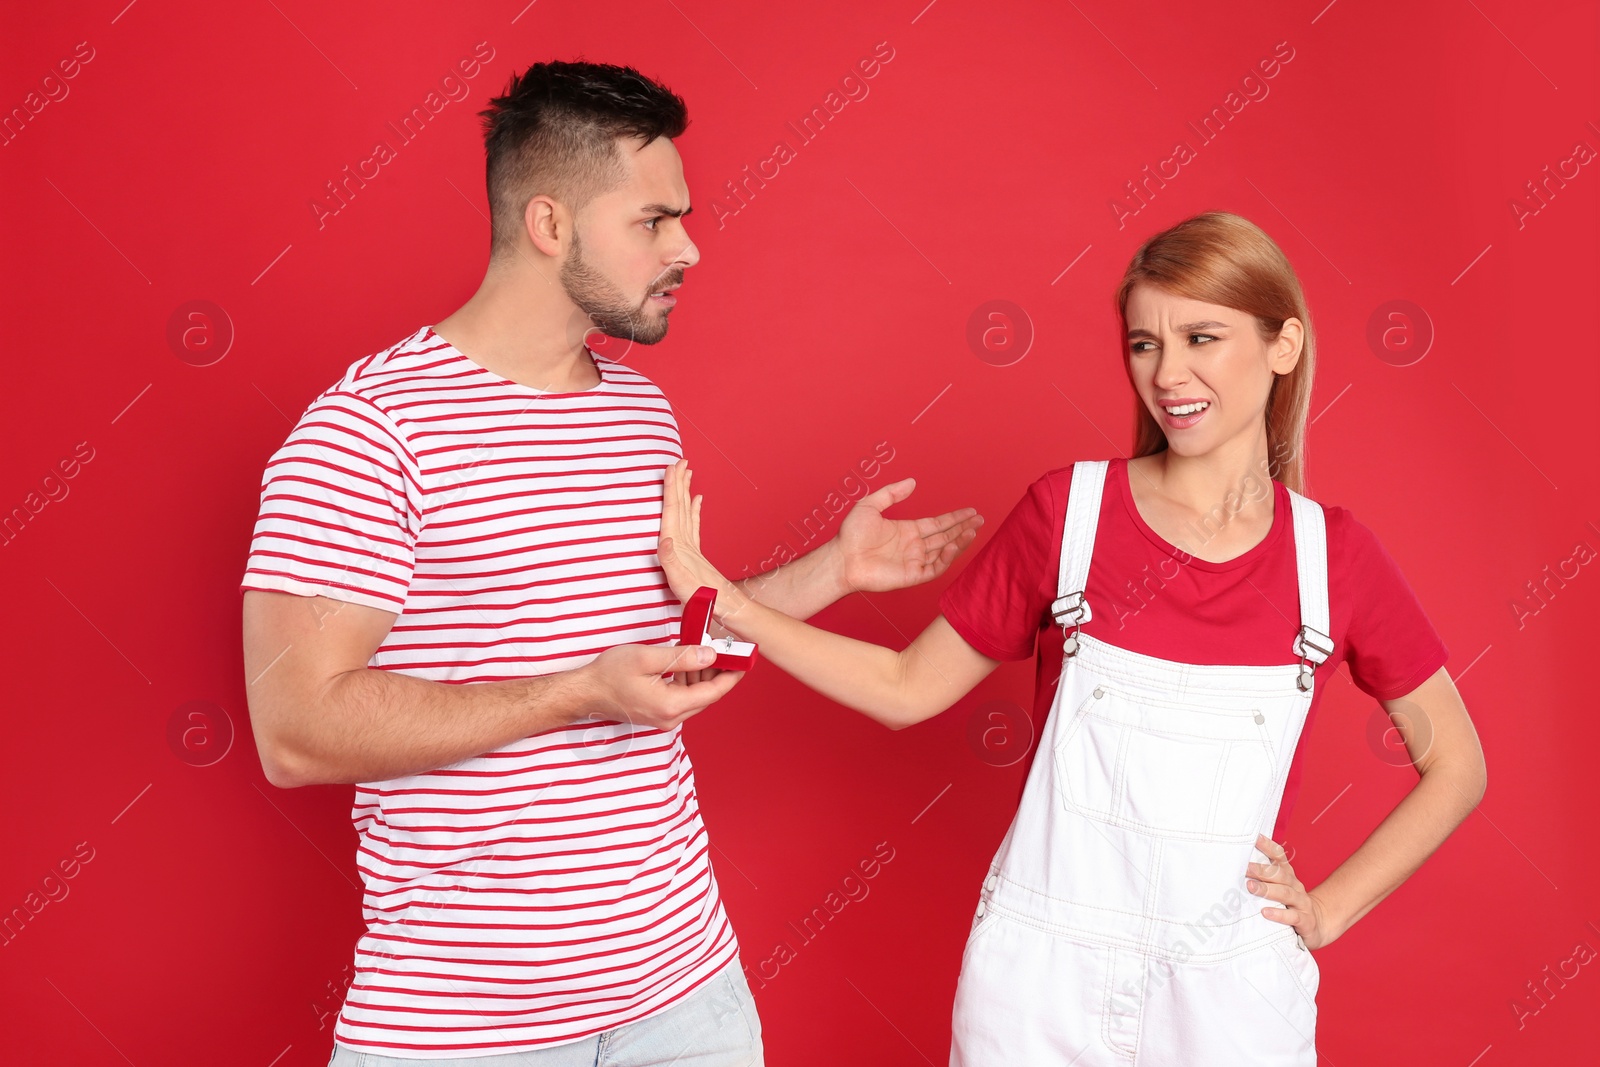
[242,326,738,1059]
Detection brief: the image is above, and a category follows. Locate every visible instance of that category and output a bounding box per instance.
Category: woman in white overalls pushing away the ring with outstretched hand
[661,213,1485,1067]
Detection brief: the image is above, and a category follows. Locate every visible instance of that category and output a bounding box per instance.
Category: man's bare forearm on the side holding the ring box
[274,667,598,785]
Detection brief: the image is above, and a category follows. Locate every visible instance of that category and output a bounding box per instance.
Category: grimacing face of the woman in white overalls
[1126,285,1302,456]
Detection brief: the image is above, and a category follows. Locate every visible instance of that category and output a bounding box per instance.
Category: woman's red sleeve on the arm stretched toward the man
[939,467,1070,659]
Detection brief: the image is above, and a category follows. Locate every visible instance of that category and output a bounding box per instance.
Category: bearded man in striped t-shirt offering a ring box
[242,62,981,1067]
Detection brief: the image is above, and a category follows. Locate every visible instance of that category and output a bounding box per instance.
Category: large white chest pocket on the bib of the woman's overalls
[1054,683,1277,841]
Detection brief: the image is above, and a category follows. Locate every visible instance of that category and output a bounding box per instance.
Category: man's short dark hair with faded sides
[478,61,688,256]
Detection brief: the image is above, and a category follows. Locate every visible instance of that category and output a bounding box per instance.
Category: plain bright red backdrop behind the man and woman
[0,0,1600,1067]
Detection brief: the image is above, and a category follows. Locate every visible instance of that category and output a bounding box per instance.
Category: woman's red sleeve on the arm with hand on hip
[1330,509,1450,701]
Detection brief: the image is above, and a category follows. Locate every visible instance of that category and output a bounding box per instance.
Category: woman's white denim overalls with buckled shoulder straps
[950,461,1333,1067]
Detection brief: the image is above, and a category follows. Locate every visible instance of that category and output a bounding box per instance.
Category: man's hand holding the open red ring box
[576,645,744,729]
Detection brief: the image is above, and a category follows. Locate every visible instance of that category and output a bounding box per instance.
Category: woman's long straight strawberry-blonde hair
[1115,211,1317,493]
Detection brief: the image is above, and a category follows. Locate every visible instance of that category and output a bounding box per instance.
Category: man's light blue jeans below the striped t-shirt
[328,957,766,1067]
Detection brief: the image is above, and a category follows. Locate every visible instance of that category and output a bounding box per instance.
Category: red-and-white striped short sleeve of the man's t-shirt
[240,392,422,614]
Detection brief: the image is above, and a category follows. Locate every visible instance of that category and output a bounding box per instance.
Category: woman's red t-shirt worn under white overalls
[939,459,1450,841]
